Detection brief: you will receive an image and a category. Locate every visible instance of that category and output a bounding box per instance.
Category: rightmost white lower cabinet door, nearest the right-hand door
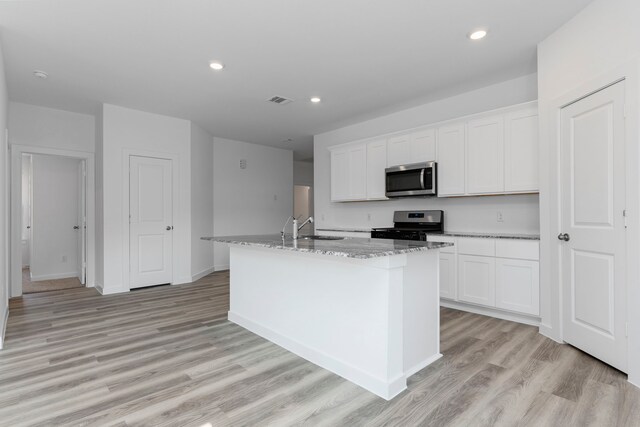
[496,258,540,316]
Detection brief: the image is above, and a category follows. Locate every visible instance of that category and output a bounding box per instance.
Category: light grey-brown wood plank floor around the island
[0,272,640,427]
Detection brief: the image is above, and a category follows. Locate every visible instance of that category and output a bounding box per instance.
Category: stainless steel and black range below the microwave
[371,211,444,241]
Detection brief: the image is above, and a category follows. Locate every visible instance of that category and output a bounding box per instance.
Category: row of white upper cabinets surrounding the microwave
[330,102,539,201]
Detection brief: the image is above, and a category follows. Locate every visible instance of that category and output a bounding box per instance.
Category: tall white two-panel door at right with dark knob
[558,82,627,371]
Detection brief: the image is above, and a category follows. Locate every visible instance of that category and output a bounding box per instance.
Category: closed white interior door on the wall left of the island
[129,156,173,288]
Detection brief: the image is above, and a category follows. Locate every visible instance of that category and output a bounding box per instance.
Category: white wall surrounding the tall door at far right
[538,0,640,385]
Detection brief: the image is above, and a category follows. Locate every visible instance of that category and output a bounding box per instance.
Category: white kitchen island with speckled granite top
[203,235,450,399]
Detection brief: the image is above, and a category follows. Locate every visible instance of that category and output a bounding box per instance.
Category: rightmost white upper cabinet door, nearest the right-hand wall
[504,107,539,192]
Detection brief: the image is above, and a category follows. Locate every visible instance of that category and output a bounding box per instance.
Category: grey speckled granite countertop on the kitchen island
[202,234,452,259]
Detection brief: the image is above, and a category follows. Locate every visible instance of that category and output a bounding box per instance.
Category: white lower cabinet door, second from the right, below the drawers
[458,255,496,307]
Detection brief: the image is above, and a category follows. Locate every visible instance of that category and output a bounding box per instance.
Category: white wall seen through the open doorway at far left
[31,154,80,281]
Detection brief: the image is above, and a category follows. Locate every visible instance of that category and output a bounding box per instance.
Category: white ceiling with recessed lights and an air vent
[0,0,591,159]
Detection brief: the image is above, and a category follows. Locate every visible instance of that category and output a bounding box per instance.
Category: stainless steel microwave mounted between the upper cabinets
[385,162,438,197]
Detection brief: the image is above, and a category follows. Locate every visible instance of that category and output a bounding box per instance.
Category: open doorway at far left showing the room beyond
[20,153,87,294]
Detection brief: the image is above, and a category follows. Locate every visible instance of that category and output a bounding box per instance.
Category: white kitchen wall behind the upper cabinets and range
[314,75,539,233]
